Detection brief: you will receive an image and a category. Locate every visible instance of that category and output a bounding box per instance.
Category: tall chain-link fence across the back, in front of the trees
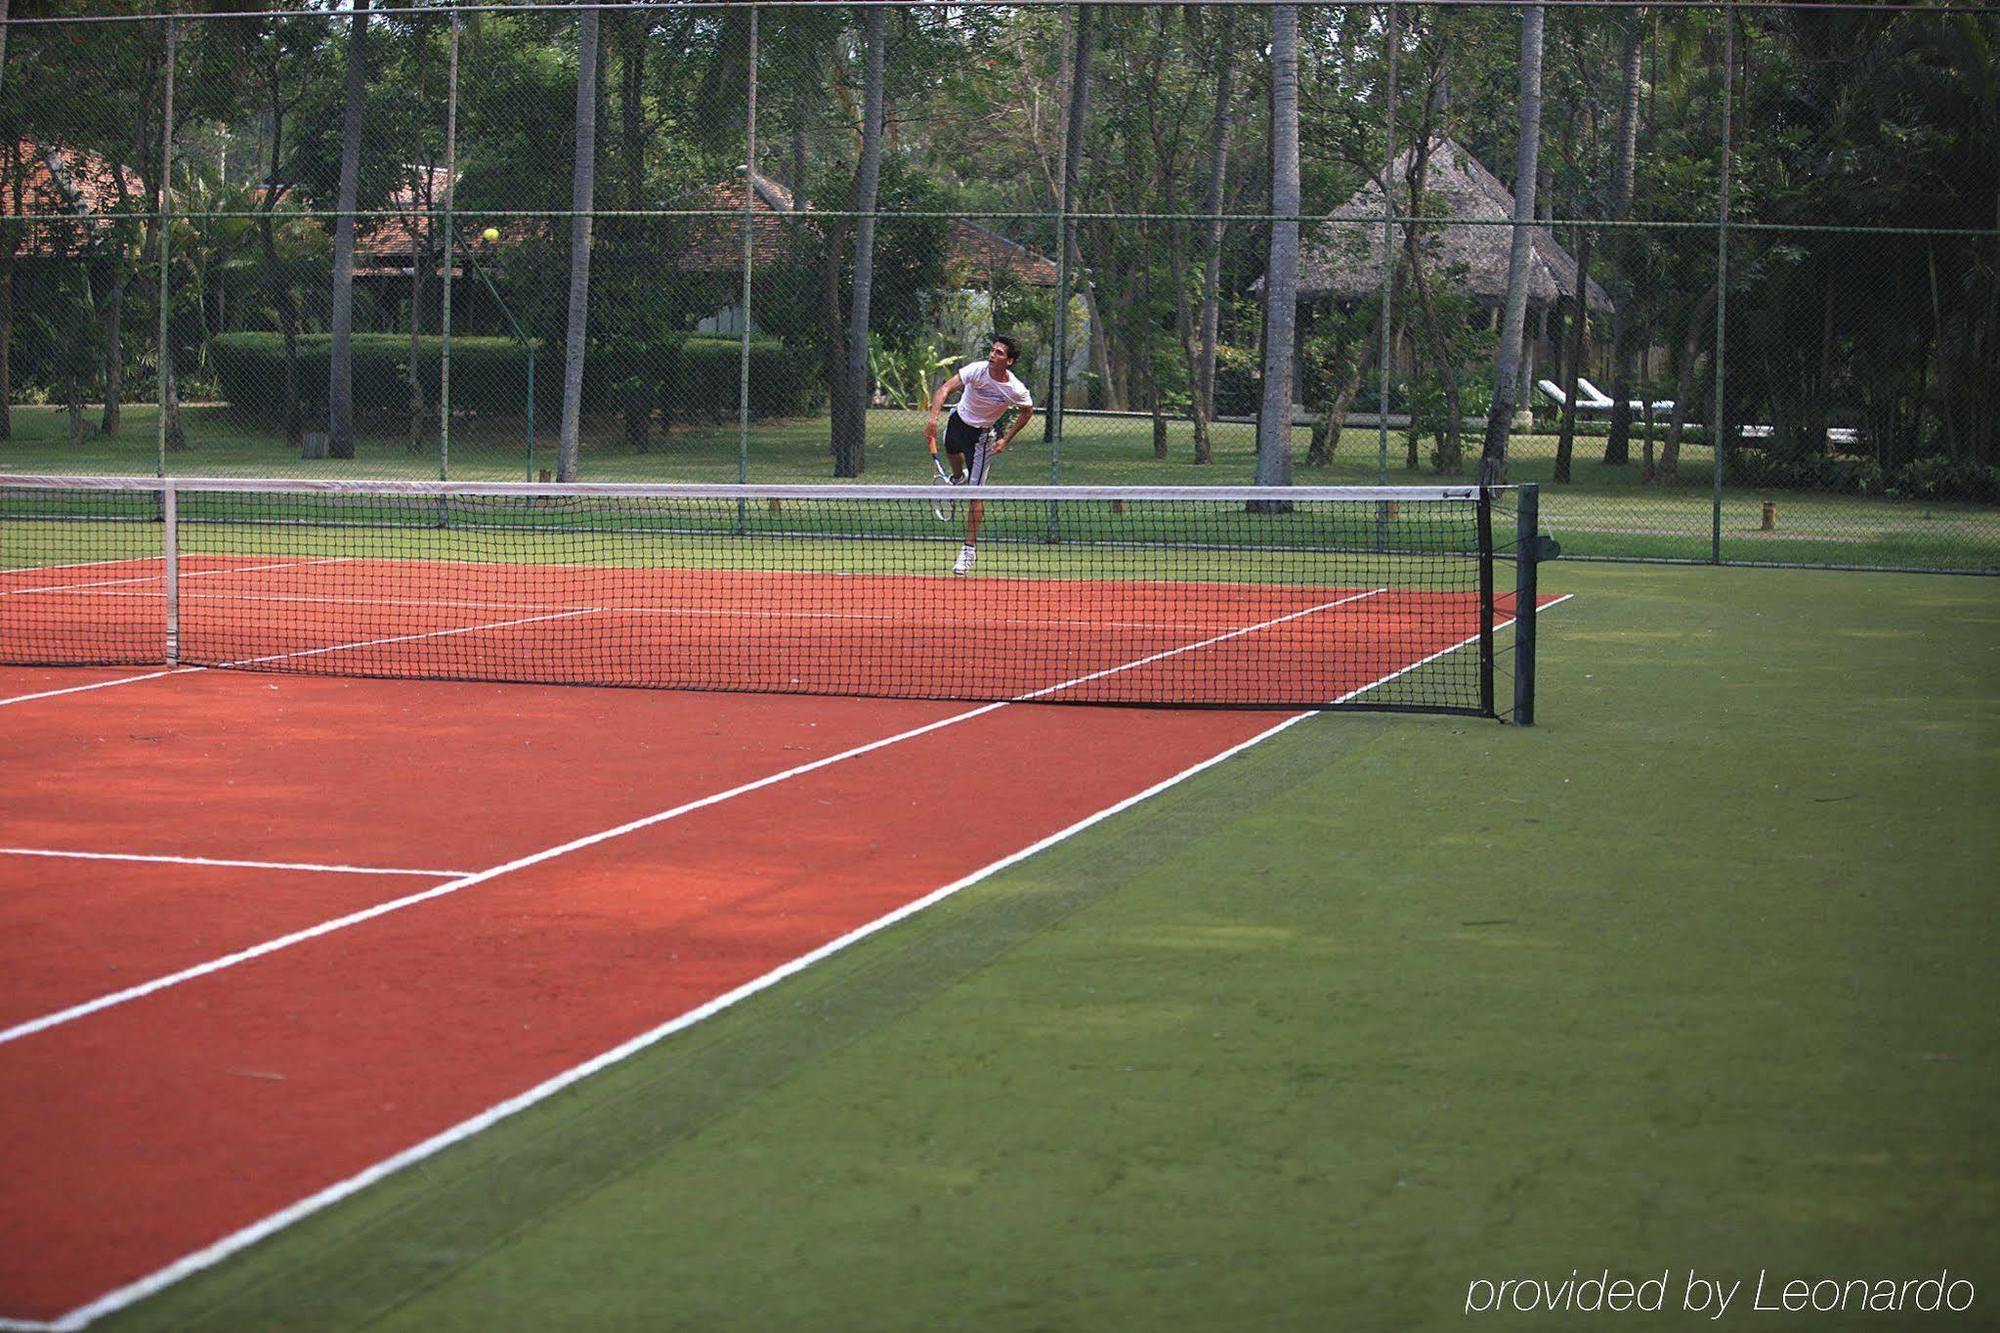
[0,0,2000,572]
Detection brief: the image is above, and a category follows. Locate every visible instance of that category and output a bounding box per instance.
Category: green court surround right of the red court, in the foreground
[104,564,2000,1331]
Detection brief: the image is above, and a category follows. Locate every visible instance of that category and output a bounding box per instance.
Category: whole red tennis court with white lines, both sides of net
[0,472,1560,1327]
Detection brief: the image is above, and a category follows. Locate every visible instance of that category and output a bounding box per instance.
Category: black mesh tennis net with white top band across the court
[0,476,1534,721]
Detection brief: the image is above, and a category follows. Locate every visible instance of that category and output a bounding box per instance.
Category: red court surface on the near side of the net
[0,570,1544,1327]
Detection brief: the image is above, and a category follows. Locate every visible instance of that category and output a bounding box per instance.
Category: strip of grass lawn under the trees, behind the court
[0,404,2000,570]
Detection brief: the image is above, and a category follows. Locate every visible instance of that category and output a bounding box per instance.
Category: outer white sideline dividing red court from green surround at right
[19,594,1570,1333]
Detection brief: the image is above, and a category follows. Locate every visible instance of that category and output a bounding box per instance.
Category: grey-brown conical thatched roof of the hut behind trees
[1298,138,1612,314]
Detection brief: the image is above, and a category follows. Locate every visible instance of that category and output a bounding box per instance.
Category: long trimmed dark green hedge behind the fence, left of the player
[210,332,824,422]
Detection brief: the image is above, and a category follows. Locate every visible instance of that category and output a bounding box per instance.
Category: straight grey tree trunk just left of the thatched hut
[1256,4,1300,486]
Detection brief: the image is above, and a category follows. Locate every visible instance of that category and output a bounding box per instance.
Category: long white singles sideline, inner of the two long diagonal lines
[0,588,1380,1047]
